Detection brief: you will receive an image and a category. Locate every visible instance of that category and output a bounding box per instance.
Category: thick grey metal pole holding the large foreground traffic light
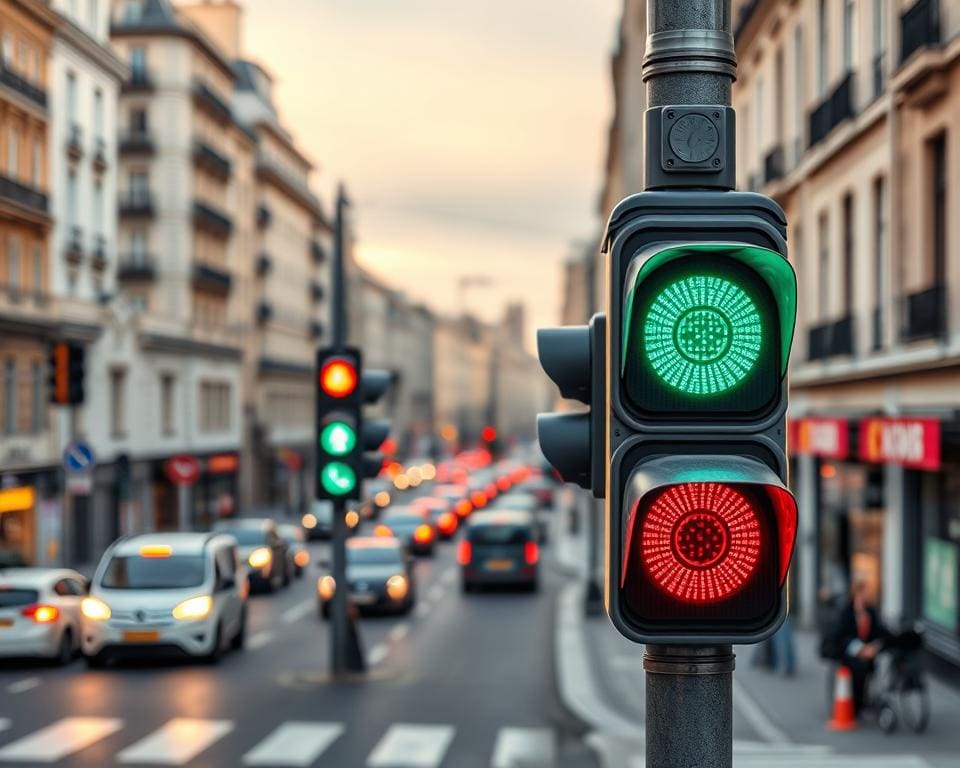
[643,0,737,768]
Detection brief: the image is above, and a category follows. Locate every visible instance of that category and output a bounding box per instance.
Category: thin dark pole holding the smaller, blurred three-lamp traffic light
[326,184,366,676]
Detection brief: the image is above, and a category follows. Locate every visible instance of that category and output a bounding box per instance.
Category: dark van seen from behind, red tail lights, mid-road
[457,511,540,592]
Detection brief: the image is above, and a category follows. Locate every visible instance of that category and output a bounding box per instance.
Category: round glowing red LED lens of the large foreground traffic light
[640,483,761,603]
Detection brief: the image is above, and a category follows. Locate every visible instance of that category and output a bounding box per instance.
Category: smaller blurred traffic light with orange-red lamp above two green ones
[316,348,391,499]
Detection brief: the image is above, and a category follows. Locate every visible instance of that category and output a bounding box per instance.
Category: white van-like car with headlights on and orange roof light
[80,533,248,667]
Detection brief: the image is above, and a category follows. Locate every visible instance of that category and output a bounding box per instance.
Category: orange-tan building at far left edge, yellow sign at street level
[0,0,60,561]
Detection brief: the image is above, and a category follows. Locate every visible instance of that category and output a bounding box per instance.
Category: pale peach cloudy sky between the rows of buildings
[244,0,620,344]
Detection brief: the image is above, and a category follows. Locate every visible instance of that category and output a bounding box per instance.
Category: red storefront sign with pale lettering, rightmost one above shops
[860,417,940,472]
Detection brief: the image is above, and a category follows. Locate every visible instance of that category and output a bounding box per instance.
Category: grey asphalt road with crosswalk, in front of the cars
[0,488,593,768]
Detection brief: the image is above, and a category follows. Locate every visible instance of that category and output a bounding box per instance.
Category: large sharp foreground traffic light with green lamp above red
[540,191,797,644]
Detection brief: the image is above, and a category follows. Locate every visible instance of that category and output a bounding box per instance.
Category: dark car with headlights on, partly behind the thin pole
[317,536,416,618]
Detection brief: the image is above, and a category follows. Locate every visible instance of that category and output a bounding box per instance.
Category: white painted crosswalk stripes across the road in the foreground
[0,717,557,768]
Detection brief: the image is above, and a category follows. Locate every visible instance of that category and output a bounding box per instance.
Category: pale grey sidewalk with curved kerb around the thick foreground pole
[554,492,960,768]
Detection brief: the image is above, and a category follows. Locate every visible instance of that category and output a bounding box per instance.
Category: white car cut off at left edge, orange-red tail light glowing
[0,568,87,664]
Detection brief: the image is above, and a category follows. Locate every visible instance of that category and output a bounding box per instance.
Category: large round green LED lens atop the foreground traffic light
[643,275,763,395]
